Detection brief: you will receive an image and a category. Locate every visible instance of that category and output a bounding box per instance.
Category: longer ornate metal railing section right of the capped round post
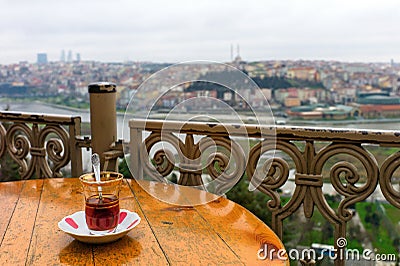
[129,119,400,265]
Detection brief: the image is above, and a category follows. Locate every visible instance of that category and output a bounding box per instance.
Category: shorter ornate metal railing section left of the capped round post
[0,112,87,181]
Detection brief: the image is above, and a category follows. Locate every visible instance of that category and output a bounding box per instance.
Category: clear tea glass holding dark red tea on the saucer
[79,172,123,235]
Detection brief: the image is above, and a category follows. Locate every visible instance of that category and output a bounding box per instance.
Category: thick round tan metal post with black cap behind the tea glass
[88,82,117,170]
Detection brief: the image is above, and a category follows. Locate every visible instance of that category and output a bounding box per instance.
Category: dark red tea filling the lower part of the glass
[85,194,119,232]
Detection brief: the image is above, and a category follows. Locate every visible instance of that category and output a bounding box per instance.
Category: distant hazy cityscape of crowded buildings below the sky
[0,50,400,120]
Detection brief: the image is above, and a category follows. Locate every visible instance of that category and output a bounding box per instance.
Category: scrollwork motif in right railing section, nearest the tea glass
[140,129,246,194]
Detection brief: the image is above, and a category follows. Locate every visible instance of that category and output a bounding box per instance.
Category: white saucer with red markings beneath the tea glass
[58,209,141,244]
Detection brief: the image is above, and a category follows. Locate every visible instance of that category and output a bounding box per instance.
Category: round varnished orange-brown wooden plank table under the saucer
[0,178,288,265]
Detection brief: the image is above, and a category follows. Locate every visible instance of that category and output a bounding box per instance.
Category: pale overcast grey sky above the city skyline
[0,0,400,64]
